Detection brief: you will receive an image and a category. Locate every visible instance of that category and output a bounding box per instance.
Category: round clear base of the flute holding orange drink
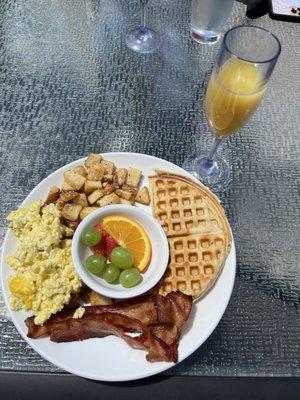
[182,151,230,190]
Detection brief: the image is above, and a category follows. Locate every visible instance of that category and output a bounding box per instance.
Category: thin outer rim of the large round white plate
[0,151,236,382]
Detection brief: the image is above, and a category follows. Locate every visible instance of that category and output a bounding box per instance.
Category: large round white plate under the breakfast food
[1,153,236,381]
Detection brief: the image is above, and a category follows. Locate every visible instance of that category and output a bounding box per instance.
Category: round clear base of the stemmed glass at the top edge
[125,28,160,54]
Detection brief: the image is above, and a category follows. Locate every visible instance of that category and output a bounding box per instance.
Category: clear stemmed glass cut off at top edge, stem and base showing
[126,0,160,53]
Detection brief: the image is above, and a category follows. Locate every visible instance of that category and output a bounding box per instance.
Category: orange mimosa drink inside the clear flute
[205,58,265,139]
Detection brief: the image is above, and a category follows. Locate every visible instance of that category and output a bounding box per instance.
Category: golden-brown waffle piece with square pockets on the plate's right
[149,171,231,299]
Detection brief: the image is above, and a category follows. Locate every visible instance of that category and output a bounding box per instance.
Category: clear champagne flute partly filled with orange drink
[183,26,281,190]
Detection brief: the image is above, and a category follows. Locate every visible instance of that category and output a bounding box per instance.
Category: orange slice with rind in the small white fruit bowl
[102,215,151,271]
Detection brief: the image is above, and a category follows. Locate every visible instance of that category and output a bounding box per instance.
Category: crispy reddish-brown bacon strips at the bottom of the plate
[25,292,192,362]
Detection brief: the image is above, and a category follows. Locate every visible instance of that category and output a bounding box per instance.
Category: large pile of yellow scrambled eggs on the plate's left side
[6,202,82,325]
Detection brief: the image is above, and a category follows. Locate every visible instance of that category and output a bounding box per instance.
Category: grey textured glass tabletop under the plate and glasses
[0,0,300,376]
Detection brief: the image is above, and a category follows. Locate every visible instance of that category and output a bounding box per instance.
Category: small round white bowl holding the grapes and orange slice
[72,204,169,299]
